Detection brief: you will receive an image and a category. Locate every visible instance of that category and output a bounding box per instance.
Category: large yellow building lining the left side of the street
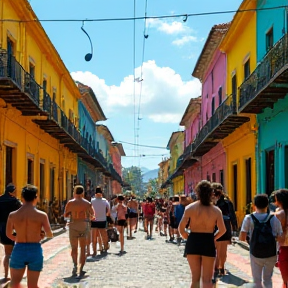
[0,0,80,204]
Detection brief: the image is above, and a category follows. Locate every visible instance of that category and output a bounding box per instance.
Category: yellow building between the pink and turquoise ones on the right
[220,0,257,223]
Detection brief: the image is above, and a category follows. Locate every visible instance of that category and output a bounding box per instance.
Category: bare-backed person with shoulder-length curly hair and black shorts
[179,180,226,288]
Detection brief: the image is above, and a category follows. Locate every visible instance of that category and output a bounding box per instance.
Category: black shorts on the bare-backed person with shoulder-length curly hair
[184,232,216,257]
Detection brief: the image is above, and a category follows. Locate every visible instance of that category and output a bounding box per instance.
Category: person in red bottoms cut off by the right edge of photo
[275,189,288,288]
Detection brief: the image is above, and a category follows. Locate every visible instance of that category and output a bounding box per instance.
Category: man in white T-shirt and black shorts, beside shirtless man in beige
[91,186,110,257]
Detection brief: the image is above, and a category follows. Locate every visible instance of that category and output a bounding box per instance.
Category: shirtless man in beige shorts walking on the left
[64,185,94,277]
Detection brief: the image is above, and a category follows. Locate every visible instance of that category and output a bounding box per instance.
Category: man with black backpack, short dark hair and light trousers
[239,194,282,288]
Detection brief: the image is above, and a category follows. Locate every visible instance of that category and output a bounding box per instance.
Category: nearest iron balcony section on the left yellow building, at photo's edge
[0,50,43,116]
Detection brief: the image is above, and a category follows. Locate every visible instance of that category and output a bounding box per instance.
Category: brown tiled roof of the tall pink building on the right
[192,22,230,82]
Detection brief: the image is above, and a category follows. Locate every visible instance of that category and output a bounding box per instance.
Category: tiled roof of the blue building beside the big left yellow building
[75,81,107,122]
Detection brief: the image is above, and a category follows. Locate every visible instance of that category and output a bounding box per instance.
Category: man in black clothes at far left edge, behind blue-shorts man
[0,183,21,280]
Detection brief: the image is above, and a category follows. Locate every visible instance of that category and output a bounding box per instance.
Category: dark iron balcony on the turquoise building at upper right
[238,34,288,114]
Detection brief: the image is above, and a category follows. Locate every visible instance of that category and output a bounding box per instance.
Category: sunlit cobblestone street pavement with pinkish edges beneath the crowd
[0,226,281,288]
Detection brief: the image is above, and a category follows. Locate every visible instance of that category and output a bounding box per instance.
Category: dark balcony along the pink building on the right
[192,95,250,157]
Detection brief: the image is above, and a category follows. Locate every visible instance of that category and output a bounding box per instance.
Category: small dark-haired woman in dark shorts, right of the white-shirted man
[116,195,127,255]
